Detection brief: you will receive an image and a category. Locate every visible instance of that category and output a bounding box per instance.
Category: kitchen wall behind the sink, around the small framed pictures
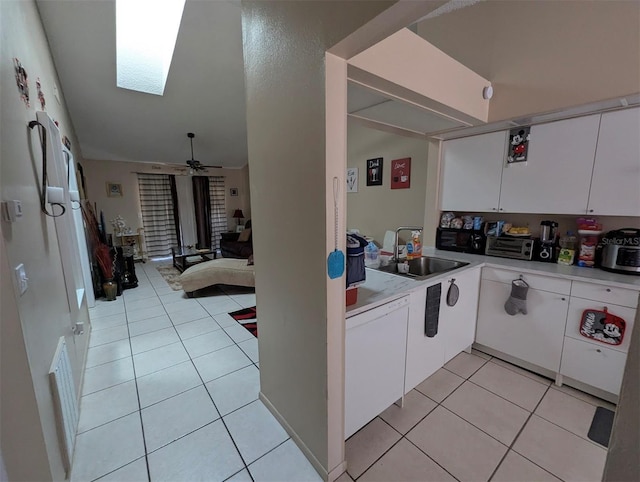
[347,120,428,246]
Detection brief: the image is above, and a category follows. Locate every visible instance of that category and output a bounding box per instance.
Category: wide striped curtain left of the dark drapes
[138,173,179,257]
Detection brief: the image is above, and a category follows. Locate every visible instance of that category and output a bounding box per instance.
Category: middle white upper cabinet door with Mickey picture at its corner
[500,114,600,214]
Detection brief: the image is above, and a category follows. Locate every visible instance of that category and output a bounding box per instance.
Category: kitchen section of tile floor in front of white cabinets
[338,350,615,482]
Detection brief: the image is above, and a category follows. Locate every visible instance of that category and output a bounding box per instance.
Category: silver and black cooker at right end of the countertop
[600,228,640,275]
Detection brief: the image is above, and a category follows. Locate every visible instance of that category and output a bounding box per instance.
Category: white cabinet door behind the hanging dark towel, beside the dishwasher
[404,286,444,393]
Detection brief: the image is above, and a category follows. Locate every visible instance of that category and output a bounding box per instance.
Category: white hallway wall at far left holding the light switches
[0,0,89,481]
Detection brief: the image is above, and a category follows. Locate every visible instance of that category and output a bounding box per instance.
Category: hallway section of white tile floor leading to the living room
[71,261,320,482]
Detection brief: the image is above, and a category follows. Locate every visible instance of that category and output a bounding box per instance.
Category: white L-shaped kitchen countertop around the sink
[346,247,640,318]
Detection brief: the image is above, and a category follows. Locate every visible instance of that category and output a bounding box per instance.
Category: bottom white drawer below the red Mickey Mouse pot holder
[560,337,627,395]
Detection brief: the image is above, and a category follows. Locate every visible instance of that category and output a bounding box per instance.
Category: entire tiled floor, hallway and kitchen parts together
[71,261,615,482]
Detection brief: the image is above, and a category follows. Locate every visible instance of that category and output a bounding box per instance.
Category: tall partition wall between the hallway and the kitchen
[242,1,389,477]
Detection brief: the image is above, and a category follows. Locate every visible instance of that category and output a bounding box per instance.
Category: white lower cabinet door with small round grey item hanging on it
[439,268,480,363]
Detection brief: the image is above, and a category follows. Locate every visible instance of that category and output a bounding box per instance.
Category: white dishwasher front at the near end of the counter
[344,296,409,439]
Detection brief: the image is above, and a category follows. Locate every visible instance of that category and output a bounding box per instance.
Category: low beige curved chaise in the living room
[180,258,256,298]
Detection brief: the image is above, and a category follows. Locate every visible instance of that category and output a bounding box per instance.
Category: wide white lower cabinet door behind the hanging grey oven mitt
[476,279,569,372]
